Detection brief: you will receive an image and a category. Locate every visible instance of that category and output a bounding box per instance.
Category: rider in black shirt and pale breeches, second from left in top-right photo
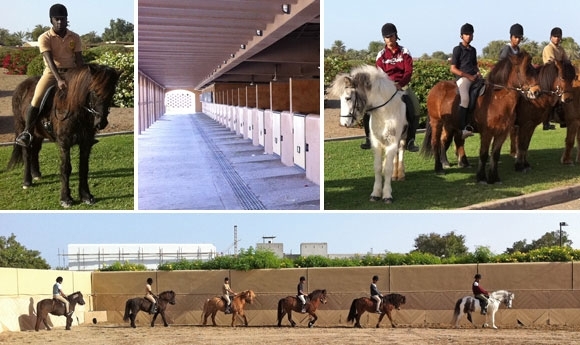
[451,23,481,139]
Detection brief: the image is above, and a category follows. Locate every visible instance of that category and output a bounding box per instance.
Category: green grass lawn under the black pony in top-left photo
[0,134,134,211]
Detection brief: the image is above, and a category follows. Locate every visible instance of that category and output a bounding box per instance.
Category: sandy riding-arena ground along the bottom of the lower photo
[0,324,578,345]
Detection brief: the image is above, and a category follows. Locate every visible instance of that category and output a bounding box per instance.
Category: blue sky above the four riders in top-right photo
[322,0,580,57]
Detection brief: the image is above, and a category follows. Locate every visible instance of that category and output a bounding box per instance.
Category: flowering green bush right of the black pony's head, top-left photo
[95,51,135,108]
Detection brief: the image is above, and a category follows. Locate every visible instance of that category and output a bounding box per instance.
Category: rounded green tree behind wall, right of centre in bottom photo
[414,231,467,257]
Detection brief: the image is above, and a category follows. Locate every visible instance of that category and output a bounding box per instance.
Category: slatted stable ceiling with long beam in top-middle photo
[137,0,320,90]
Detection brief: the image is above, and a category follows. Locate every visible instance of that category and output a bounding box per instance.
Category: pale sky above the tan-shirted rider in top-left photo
[0,0,135,35]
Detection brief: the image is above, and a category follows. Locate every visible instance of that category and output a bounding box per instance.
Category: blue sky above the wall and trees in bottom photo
[0,211,580,267]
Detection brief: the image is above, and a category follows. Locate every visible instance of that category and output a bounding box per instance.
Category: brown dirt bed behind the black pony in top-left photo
[0,68,134,144]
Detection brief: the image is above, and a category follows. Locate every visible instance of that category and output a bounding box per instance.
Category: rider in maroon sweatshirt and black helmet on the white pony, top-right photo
[361,23,419,152]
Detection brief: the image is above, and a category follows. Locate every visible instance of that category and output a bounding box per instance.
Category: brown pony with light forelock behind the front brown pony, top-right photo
[511,61,577,172]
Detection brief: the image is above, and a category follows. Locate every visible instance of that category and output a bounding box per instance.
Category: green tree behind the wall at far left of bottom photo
[0,234,50,269]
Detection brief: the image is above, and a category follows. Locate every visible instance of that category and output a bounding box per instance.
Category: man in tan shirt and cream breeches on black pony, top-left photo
[16,4,84,147]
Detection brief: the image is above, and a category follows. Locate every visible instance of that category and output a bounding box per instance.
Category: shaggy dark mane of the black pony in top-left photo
[62,64,119,112]
